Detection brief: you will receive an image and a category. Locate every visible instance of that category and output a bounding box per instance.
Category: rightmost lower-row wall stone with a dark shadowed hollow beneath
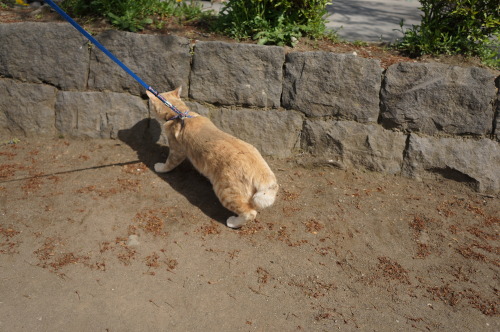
[402,134,500,193]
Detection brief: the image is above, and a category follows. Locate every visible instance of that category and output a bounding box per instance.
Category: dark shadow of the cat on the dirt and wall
[118,119,232,224]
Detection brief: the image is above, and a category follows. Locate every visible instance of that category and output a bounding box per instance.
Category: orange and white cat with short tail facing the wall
[147,87,278,228]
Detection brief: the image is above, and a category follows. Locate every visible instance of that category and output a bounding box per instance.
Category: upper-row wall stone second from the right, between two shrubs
[282,52,382,122]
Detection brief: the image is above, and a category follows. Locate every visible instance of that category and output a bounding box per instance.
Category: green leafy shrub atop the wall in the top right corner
[396,0,500,67]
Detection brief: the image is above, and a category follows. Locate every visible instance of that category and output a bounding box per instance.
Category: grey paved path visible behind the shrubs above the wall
[203,0,420,41]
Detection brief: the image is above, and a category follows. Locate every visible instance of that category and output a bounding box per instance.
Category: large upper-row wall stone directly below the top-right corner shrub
[381,62,496,135]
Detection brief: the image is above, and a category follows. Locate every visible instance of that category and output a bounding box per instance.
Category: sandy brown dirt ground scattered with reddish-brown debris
[0,131,500,331]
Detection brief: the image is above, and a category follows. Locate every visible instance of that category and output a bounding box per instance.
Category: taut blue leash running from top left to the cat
[45,0,191,120]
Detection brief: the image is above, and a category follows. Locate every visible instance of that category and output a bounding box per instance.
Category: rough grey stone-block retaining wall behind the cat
[0,23,500,193]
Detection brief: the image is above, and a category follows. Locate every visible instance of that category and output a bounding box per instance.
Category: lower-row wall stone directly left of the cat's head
[56,91,149,138]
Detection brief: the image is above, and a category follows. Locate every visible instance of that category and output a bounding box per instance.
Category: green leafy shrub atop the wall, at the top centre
[215,0,328,45]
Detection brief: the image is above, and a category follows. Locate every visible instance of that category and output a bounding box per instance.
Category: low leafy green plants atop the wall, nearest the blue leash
[61,0,202,31]
